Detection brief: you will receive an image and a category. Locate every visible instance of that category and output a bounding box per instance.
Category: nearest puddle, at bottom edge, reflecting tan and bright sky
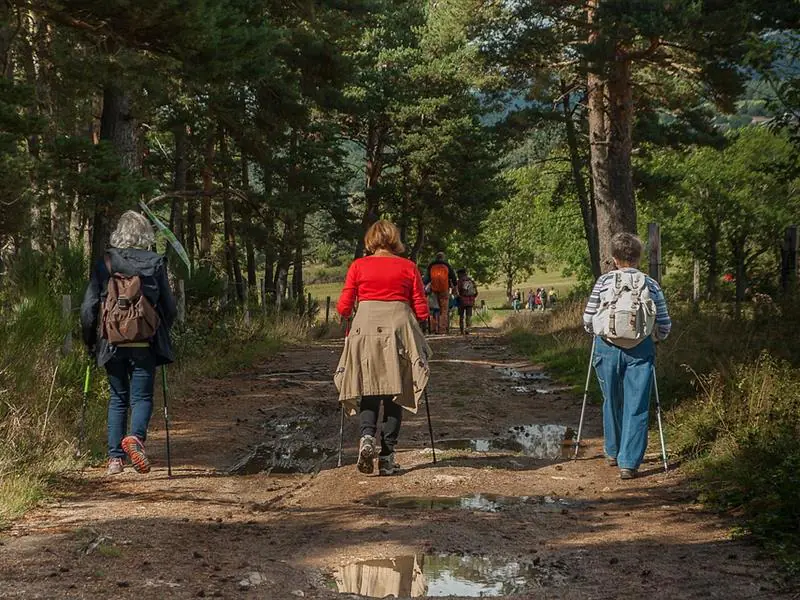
[331,554,566,598]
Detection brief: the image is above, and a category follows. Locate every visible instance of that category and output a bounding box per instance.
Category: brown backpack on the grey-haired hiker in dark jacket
[102,255,160,344]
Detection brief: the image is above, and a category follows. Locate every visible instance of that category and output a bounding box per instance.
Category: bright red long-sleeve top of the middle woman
[336,256,429,321]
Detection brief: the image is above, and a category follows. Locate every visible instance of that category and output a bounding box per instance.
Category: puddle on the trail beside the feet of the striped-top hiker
[428,424,580,460]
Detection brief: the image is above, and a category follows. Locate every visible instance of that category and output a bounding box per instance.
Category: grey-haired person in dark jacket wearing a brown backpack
[81,211,178,475]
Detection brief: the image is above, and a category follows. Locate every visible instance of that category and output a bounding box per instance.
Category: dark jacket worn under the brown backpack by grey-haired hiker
[81,248,178,367]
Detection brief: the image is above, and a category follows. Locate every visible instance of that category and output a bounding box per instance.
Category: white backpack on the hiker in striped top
[592,271,656,348]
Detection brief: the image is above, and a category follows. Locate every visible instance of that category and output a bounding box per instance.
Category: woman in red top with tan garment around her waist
[333,221,432,475]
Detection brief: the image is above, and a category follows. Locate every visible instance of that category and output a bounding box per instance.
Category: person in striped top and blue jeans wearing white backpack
[583,233,672,479]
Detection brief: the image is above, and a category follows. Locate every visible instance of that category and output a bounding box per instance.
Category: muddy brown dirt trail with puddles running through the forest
[0,331,789,599]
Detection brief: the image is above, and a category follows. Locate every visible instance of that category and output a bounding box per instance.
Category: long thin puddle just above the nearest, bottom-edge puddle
[359,494,579,513]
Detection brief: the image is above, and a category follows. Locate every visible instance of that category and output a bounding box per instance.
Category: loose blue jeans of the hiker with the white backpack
[593,337,655,469]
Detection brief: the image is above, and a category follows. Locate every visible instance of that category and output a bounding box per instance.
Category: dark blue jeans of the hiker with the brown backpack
[106,348,156,458]
